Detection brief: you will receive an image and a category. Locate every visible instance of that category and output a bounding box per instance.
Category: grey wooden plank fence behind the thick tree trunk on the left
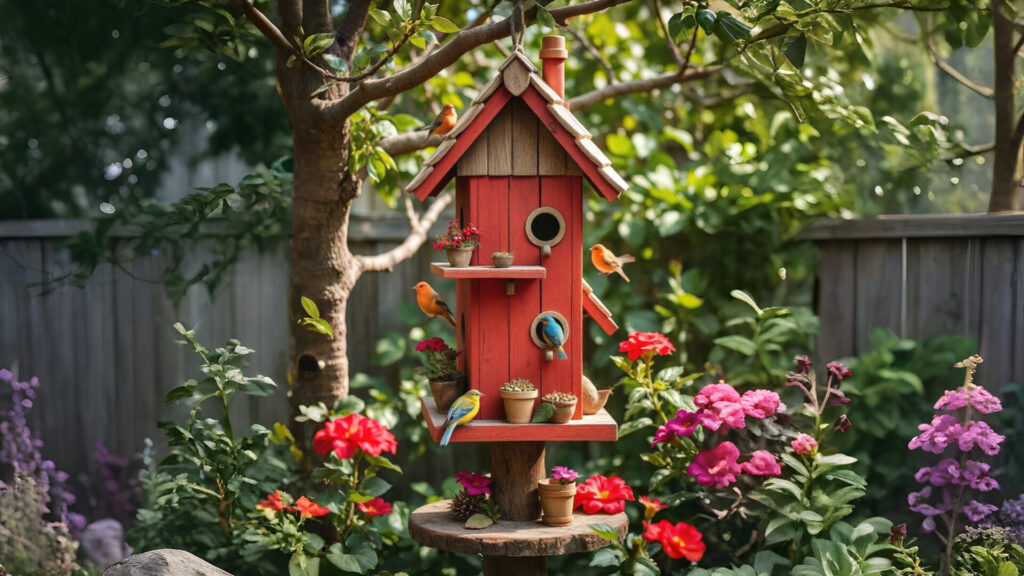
[0,215,444,483]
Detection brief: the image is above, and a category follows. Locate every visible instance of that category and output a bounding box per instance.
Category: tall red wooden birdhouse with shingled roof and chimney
[406,37,628,442]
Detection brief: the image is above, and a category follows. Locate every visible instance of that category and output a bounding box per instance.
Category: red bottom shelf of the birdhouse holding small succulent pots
[420,397,618,442]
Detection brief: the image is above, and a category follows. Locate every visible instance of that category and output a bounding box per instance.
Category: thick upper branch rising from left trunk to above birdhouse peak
[327,0,631,119]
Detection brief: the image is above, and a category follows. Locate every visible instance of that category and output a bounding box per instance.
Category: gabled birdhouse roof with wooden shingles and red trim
[406,49,629,202]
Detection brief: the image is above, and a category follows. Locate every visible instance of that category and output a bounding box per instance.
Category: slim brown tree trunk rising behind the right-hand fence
[988,0,1022,212]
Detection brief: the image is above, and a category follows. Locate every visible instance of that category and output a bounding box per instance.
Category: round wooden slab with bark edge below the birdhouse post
[409,500,630,557]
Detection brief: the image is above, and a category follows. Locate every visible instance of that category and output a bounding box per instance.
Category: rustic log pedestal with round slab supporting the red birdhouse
[409,442,629,576]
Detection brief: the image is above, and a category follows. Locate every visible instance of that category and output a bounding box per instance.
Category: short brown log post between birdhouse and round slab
[490,442,547,522]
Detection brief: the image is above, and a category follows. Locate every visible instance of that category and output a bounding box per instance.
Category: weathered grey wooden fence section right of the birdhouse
[805,214,1024,389]
